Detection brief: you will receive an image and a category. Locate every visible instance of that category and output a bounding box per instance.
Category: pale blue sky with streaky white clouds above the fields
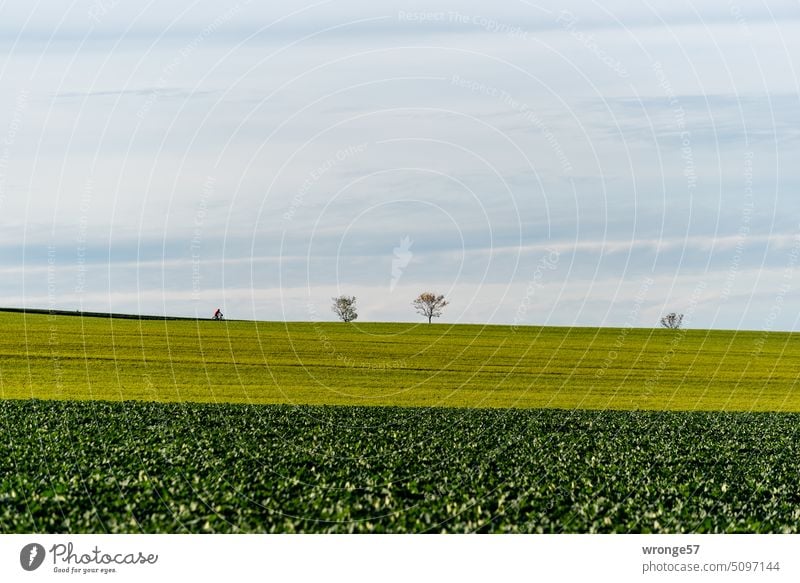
[0,0,800,330]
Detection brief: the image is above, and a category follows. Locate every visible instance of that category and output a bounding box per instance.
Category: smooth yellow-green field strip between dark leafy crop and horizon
[0,313,800,411]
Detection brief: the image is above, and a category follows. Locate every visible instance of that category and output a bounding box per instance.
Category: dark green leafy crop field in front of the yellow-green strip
[0,401,800,533]
